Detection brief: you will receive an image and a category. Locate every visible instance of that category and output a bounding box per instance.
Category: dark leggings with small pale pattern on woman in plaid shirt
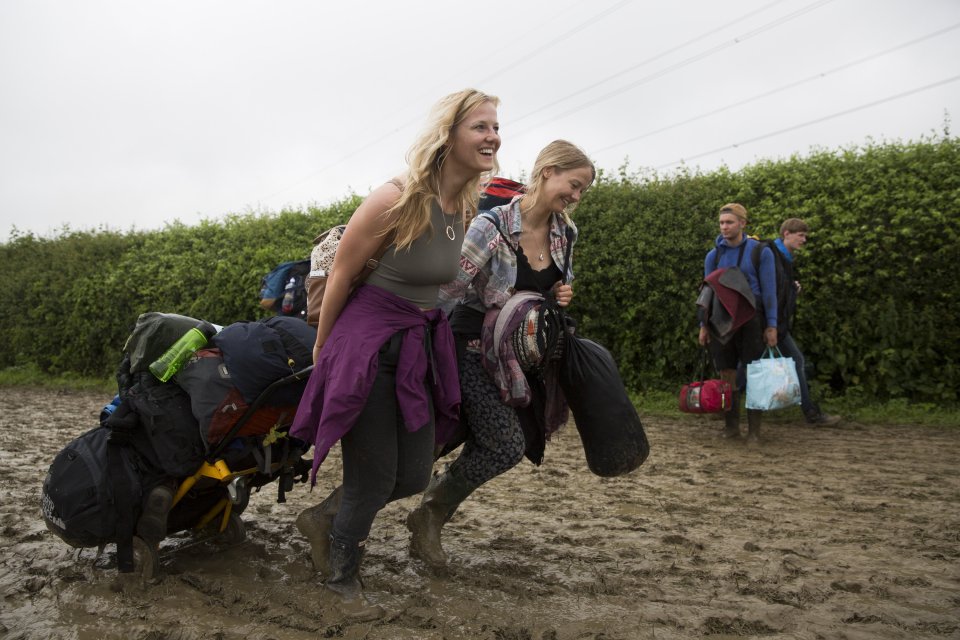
[450,351,526,486]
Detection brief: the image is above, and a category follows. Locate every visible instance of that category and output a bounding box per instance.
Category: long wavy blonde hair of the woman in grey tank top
[385,89,500,249]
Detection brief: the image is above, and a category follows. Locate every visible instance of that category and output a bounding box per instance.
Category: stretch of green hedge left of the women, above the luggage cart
[0,197,359,376]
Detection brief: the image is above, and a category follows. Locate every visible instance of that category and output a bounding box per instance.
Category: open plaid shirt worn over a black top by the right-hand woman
[437,196,577,313]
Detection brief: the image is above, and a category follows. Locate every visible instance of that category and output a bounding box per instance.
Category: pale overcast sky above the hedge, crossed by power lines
[0,0,960,241]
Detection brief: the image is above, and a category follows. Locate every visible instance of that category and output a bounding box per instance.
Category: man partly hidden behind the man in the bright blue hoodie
[774,218,840,426]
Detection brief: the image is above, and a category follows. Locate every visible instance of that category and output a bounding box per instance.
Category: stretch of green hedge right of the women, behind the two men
[575,137,960,401]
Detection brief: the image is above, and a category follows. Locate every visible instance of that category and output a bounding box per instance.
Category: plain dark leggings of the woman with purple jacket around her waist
[333,332,435,542]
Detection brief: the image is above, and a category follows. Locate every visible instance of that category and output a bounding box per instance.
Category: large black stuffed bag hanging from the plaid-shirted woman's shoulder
[560,334,650,477]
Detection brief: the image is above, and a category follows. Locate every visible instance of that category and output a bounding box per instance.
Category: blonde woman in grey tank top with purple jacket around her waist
[290,89,500,608]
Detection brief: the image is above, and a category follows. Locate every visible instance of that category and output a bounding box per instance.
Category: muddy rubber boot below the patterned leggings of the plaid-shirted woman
[407,469,477,569]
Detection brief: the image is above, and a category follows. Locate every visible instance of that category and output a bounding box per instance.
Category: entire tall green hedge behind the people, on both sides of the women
[0,136,960,401]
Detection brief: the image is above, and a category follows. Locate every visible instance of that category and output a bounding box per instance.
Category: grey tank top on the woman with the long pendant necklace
[367,201,463,309]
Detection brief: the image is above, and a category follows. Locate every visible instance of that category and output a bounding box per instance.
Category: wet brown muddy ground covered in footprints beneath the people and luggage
[0,388,960,640]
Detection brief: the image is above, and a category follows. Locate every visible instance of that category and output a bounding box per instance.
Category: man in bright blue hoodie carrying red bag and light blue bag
[699,202,777,445]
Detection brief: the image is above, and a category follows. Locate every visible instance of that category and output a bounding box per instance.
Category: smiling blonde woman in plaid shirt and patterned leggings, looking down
[407,140,596,568]
